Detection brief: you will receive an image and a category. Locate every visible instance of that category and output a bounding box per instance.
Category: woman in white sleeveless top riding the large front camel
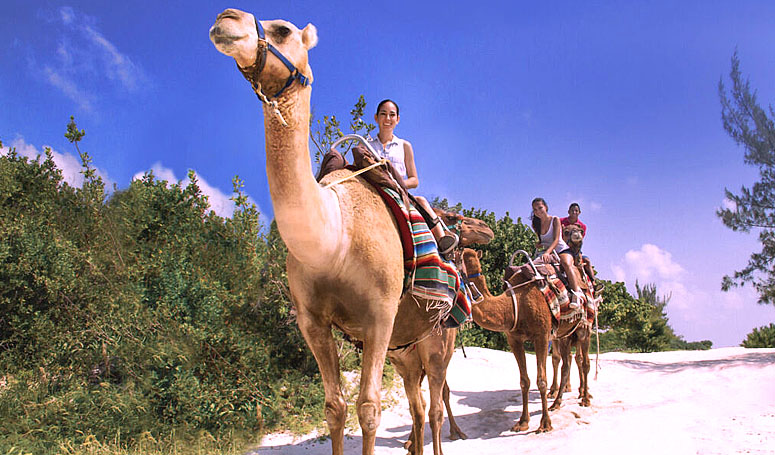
[369,99,458,255]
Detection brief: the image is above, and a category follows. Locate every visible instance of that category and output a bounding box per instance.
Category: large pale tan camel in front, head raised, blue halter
[210,9,492,455]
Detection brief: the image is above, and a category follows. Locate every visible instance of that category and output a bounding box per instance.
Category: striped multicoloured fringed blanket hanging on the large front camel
[380,188,471,328]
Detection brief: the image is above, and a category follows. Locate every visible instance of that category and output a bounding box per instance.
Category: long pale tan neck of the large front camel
[264,85,341,269]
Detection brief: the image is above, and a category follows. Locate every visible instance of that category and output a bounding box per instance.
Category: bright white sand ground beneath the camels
[251,348,775,455]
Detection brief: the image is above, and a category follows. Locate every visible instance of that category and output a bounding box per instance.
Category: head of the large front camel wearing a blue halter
[210,8,318,94]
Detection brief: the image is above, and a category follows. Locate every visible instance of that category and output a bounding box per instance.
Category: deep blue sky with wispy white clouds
[0,0,775,347]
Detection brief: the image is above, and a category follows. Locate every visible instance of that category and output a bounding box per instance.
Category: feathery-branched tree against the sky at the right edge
[716,51,775,305]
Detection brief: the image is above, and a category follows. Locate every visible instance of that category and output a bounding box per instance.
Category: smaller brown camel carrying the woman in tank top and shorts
[463,248,596,433]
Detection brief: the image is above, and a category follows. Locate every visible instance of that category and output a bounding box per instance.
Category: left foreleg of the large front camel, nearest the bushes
[297,313,347,455]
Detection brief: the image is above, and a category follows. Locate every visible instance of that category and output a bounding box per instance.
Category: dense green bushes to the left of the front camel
[0,118,323,453]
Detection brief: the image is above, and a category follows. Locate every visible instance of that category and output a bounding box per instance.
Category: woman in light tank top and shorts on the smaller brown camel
[531,197,584,308]
